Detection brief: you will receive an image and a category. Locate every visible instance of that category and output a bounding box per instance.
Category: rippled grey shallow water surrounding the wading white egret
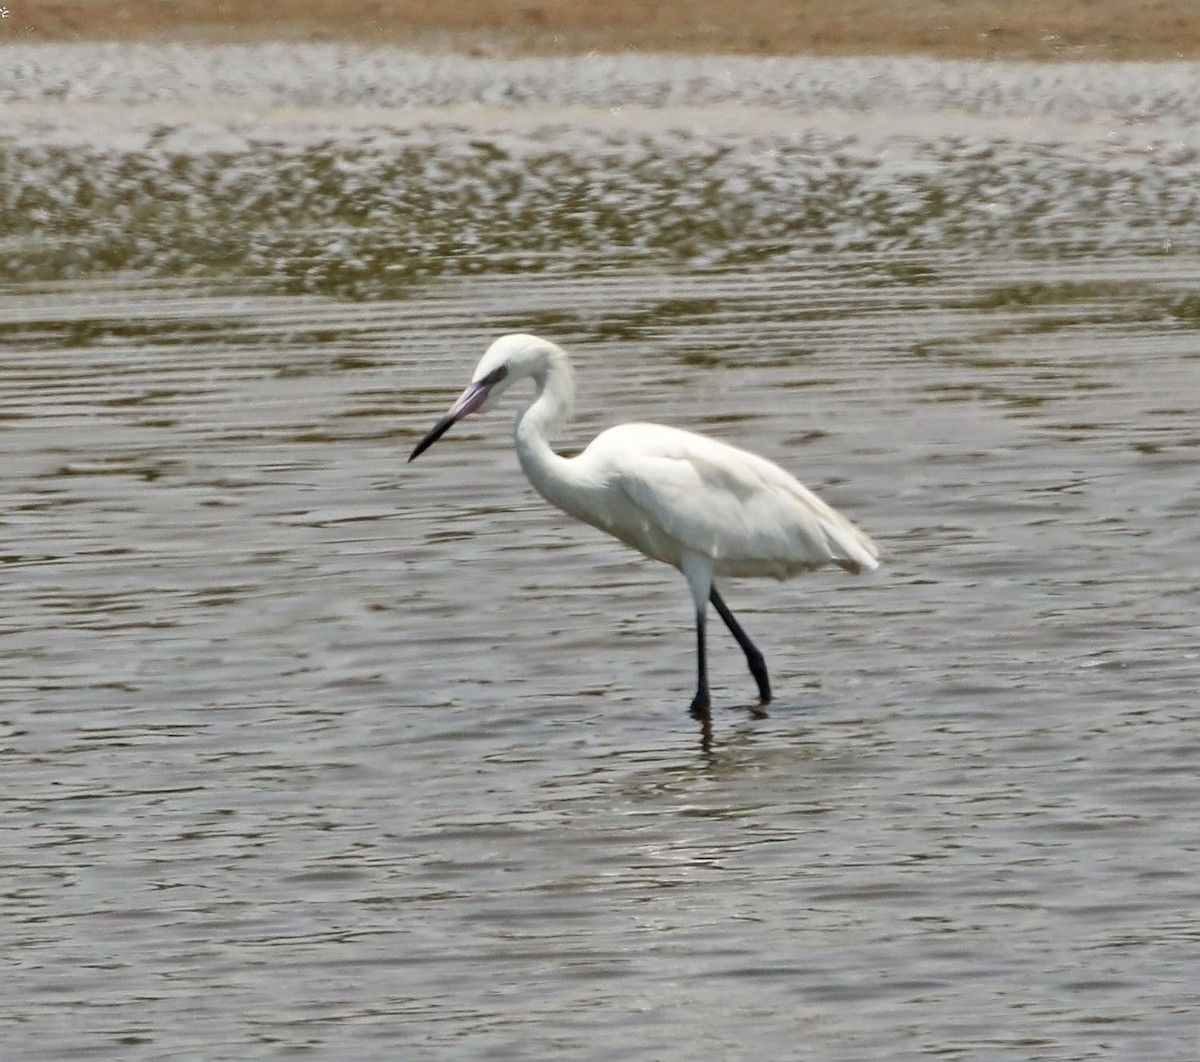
[0,48,1200,1060]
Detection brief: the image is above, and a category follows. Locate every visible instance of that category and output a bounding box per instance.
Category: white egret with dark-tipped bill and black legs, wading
[408,334,878,716]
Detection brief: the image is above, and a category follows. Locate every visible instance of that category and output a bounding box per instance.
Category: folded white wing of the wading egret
[617,426,877,578]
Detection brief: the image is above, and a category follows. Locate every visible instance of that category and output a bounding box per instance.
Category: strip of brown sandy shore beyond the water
[7,0,1200,60]
